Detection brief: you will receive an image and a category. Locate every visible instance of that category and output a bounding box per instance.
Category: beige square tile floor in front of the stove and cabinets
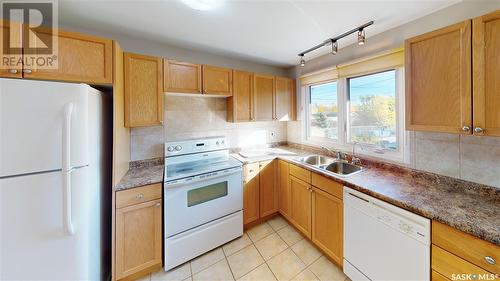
[137,216,349,281]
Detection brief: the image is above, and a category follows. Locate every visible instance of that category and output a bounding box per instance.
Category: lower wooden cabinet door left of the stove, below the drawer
[116,200,162,279]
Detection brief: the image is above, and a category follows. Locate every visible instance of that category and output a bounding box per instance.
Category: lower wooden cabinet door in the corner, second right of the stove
[259,160,279,217]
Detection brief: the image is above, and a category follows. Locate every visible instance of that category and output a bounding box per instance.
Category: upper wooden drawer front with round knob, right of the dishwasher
[432,221,500,274]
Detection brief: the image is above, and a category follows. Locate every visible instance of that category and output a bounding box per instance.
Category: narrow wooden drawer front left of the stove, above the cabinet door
[116,183,161,209]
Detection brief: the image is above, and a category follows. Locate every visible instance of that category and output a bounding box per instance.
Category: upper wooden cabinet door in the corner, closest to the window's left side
[274,77,295,121]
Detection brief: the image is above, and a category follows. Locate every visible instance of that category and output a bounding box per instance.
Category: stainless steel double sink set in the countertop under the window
[299,155,363,177]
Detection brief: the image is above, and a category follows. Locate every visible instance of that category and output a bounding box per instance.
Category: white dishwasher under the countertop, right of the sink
[344,187,431,281]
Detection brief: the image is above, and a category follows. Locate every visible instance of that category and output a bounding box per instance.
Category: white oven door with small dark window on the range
[165,167,243,238]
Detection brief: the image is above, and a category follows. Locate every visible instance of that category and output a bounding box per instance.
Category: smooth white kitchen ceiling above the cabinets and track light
[59,0,459,67]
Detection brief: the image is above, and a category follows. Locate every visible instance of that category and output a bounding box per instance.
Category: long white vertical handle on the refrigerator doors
[62,103,75,235]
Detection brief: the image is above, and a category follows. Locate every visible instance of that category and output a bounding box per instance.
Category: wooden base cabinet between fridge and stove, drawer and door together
[115,184,162,280]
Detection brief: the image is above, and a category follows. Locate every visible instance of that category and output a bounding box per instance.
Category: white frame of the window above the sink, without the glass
[302,66,410,164]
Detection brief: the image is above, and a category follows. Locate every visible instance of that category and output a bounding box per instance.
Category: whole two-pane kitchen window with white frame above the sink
[303,67,408,162]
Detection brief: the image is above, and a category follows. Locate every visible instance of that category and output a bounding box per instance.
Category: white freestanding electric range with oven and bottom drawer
[164,137,243,271]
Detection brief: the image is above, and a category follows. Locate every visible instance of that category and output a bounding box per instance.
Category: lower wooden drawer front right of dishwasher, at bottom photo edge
[432,245,493,280]
